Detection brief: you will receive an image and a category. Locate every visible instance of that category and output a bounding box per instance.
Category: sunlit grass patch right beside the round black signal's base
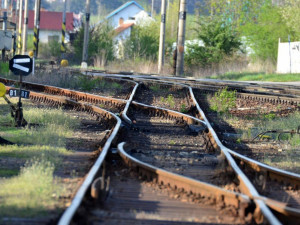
[0,107,78,147]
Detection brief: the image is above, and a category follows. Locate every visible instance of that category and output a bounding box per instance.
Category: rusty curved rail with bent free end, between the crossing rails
[118,142,251,216]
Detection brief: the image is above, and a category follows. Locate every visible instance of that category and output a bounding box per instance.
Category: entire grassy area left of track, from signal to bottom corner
[0,99,79,218]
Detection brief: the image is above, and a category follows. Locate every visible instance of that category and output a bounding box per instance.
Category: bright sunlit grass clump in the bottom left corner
[0,159,62,217]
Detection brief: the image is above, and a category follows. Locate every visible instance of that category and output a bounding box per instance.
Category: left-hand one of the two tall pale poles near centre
[158,0,167,73]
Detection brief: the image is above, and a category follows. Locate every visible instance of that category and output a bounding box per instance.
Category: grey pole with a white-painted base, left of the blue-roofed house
[81,0,90,68]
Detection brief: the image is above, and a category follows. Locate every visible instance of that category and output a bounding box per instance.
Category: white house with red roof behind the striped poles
[28,10,74,43]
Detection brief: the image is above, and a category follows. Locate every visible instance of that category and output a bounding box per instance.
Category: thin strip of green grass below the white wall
[209,72,300,82]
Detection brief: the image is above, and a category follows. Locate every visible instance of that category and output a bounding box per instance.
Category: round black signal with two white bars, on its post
[9,55,33,127]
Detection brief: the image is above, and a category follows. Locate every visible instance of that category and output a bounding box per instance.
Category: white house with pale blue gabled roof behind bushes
[105,1,153,58]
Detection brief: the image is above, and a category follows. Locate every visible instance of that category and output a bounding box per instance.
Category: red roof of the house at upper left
[28,10,74,31]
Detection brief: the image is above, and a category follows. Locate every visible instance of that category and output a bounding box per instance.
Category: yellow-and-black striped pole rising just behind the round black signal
[33,0,41,58]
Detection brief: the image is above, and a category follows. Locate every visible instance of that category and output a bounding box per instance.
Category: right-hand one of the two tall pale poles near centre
[176,0,186,76]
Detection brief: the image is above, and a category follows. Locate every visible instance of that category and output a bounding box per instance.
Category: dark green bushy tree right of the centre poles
[185,16,241,67]
